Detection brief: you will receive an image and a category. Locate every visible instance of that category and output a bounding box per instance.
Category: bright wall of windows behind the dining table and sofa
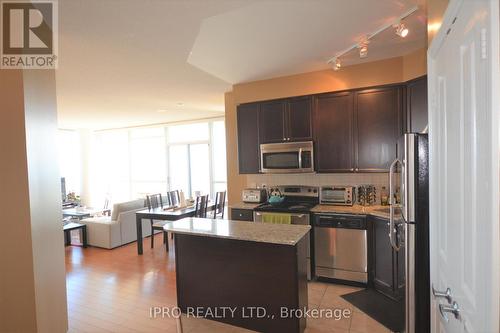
[93,120,227,202]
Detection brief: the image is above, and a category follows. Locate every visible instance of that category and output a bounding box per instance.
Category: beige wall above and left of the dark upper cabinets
[225,50,427,204]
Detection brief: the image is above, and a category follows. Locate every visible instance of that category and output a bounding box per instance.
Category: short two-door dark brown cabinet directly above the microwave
[259,96,312,143]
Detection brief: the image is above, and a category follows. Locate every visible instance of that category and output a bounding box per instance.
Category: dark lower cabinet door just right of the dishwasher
[372,218,394,297]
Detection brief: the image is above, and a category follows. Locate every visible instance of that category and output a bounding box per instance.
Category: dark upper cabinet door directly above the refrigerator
[406,76,428,133]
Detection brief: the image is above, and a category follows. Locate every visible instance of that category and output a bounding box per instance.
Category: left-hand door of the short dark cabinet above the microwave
[259,100,286,143]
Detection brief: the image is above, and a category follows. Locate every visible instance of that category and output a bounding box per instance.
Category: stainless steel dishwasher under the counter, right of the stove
[314,214,368,283]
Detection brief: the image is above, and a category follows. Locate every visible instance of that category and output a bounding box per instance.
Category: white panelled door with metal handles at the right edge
[428,0,500,333]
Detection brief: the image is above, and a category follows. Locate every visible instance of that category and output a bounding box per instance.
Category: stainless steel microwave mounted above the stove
[260,141,314,173]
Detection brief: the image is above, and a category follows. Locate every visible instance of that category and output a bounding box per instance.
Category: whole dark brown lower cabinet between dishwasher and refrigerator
[369,216,405,299]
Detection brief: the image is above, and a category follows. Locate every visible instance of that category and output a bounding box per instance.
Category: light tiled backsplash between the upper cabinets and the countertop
[246,173,389,202]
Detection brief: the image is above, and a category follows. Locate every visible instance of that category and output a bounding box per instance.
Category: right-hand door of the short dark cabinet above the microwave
[286,97,312,141]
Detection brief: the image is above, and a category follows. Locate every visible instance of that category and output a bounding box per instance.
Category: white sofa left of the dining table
[81,199,156,249]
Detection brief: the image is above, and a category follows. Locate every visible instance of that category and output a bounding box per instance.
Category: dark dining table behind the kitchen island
[135,202,215,255]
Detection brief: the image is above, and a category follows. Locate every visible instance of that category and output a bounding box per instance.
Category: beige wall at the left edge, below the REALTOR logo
[0,70,68,332]
